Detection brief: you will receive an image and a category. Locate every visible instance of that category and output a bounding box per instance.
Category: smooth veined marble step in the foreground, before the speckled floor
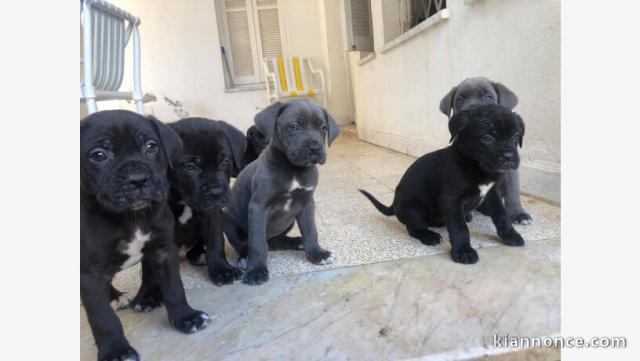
[81,238,560,361]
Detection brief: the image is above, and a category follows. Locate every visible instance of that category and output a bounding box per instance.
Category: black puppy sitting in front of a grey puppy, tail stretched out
[360,105,524,263]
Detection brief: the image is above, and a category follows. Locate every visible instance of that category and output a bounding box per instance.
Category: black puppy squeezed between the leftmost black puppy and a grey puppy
[169,118,245,286]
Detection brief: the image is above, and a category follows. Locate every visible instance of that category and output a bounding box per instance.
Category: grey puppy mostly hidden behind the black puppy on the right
[440,77,532,224]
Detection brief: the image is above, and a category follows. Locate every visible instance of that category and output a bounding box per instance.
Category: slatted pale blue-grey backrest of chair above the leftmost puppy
[83,0,139,91]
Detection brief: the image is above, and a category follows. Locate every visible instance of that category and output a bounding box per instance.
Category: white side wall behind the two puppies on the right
[350,0,560,201]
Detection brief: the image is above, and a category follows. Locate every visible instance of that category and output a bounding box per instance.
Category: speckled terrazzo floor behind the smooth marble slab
[115,125,560,293]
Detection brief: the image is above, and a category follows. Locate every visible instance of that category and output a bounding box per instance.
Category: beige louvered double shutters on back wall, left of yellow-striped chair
[216,0,283,87]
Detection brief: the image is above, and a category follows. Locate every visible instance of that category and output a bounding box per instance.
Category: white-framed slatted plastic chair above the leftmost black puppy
[80,0,143,114]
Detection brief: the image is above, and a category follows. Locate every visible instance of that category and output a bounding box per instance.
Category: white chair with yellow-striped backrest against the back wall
[262,56,327,108]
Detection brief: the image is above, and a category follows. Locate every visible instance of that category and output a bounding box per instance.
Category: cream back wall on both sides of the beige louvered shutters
[98,0,349,131]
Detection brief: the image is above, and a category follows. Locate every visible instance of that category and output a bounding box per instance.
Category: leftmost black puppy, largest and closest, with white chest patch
[80,110,209,360]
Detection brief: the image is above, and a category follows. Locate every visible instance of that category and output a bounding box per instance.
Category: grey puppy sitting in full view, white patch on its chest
[224,99,340,285]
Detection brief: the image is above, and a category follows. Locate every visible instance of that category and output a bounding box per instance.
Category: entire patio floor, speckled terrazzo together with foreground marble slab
[81,127,560,360]
